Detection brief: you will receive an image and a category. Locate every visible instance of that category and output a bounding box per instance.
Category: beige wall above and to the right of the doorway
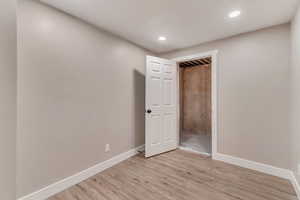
[161,24,290,169]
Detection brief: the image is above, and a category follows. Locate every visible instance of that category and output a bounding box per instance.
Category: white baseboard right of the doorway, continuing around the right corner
[213,153,300,200]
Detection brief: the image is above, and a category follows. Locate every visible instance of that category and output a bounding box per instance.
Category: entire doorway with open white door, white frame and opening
[145,50,218,159]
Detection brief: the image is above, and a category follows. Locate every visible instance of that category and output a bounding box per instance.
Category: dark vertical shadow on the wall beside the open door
[133,69,145,147]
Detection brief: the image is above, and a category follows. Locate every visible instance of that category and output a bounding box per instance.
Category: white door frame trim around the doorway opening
[171,50,219,159]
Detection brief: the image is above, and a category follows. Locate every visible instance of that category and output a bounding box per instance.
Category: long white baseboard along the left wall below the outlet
[18,145,144,200]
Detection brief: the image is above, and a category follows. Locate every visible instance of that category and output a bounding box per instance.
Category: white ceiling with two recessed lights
[41,0,298,53]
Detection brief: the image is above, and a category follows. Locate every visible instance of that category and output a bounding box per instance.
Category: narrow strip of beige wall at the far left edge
[0,0,17,200]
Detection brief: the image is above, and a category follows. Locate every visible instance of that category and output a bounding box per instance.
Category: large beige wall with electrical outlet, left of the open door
[17,0,149,197]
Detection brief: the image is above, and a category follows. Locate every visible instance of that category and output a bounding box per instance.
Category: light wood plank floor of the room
[49,150,297,200]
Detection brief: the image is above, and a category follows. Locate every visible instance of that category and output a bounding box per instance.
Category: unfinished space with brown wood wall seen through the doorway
[179,57,212,154]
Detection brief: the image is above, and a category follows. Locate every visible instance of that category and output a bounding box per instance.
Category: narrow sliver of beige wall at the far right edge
[290,5,300,183]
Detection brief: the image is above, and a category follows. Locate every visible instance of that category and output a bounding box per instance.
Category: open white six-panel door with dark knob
[145,56,178,157]
